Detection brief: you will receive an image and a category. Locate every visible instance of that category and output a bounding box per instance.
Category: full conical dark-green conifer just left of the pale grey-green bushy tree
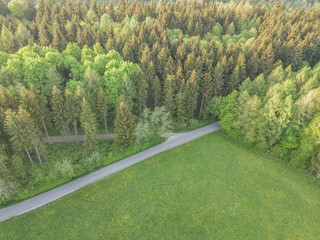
[114,98,134,150]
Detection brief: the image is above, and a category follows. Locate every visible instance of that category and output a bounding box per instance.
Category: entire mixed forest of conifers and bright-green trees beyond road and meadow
[0,0,320,202]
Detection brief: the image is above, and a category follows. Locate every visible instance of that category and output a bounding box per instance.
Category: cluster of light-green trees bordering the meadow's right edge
[215,62,320,177]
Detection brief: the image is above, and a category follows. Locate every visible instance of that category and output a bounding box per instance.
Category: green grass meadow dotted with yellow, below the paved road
[0,132,320,239]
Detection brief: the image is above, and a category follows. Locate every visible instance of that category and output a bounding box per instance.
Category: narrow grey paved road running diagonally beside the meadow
[0,123,221,222]
